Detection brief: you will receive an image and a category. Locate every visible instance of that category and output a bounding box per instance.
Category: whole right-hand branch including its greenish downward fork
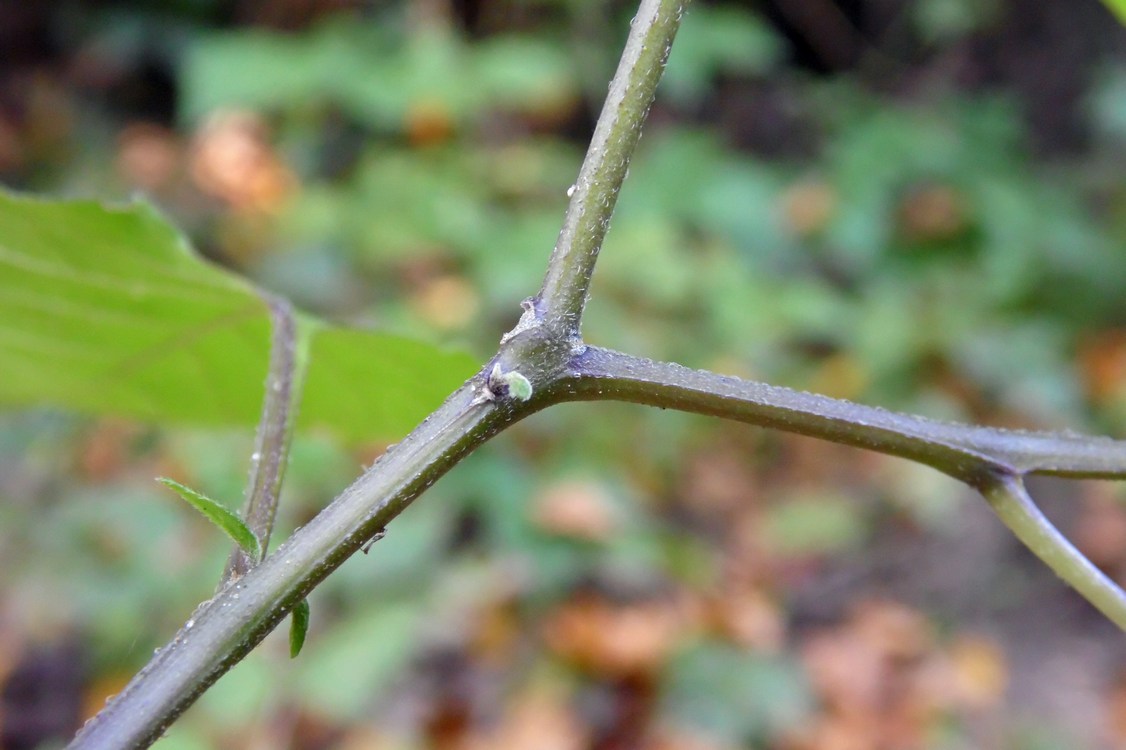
[556,347,1126,631]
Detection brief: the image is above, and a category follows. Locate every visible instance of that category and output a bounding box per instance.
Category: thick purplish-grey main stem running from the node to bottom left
[69,374,522,750]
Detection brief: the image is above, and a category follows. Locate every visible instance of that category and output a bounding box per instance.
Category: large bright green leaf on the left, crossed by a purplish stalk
[0,190,475,441]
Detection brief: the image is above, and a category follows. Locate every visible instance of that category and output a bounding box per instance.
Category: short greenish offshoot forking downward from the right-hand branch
[977,473,1126,631]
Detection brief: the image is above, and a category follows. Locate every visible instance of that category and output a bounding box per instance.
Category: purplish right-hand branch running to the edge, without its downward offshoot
[564,347,1126,483]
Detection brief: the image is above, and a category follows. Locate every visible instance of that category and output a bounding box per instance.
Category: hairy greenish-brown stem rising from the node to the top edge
[537,0,687,338]
